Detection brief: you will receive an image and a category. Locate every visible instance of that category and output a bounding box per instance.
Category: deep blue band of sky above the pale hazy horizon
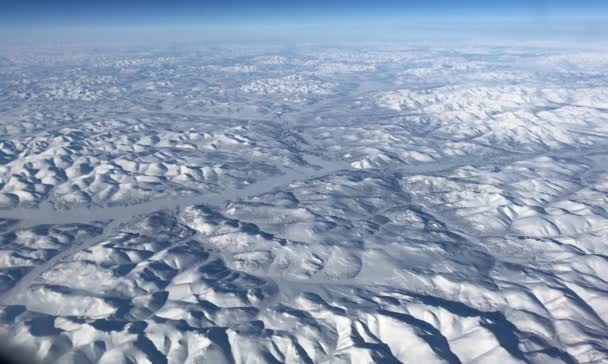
[0,0,608,24]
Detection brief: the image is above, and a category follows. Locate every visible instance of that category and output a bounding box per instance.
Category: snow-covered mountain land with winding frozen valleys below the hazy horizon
[0,44,608,364]
